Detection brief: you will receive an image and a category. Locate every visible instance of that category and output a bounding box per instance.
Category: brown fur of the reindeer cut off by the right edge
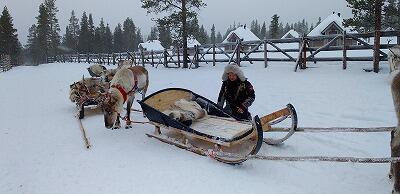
[390,71,400,194]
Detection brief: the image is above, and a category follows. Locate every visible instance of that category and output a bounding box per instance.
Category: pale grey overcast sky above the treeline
[0,0,351,44]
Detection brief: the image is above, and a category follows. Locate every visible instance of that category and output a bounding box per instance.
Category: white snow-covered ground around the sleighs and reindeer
[0,62,396,194]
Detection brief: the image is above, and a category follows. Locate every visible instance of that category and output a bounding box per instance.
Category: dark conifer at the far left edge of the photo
[0,7,21,65]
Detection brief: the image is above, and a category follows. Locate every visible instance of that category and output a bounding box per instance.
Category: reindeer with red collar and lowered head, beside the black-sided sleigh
[102,66,149,129]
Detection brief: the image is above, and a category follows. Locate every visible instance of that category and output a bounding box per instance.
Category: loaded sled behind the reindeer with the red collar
[70,77,108,119]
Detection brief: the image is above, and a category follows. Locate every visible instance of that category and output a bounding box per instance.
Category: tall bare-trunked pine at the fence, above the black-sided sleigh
[141,0,206,68]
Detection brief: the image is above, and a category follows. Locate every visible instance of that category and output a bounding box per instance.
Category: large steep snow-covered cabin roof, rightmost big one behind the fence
[308,13,355,36]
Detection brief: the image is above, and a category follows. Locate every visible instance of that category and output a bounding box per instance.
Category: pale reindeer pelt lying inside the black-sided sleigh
[163,99,207,122]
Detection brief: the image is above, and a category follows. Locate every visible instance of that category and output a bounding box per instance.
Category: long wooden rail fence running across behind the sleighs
[48,31,400,71]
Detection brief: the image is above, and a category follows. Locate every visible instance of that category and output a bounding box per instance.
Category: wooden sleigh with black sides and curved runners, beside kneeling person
[139,88,297,164]
